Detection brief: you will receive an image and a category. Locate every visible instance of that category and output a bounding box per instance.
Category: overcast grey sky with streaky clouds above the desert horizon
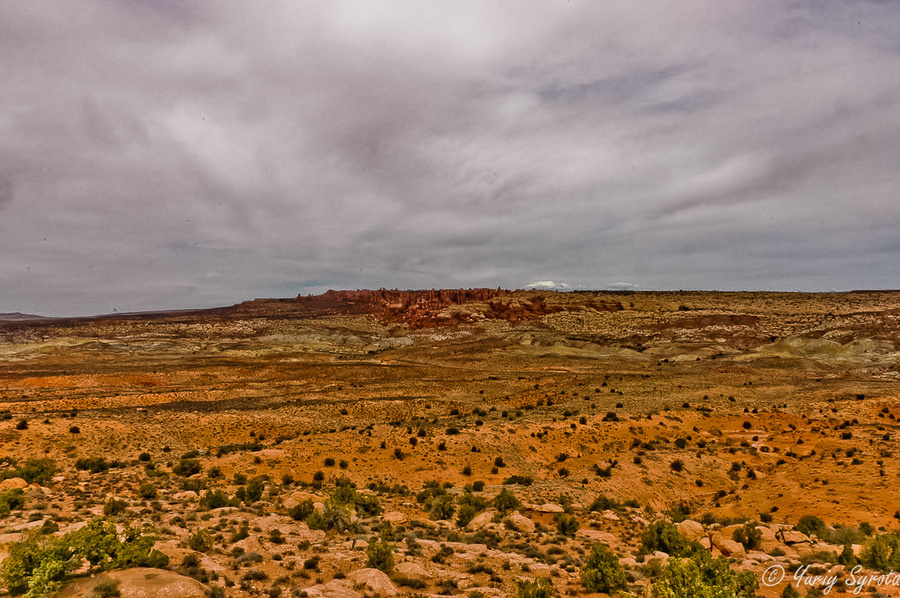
[0,0,900,316]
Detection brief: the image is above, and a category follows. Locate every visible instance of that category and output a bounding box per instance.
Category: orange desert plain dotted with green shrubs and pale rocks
[0,289,900,598]
